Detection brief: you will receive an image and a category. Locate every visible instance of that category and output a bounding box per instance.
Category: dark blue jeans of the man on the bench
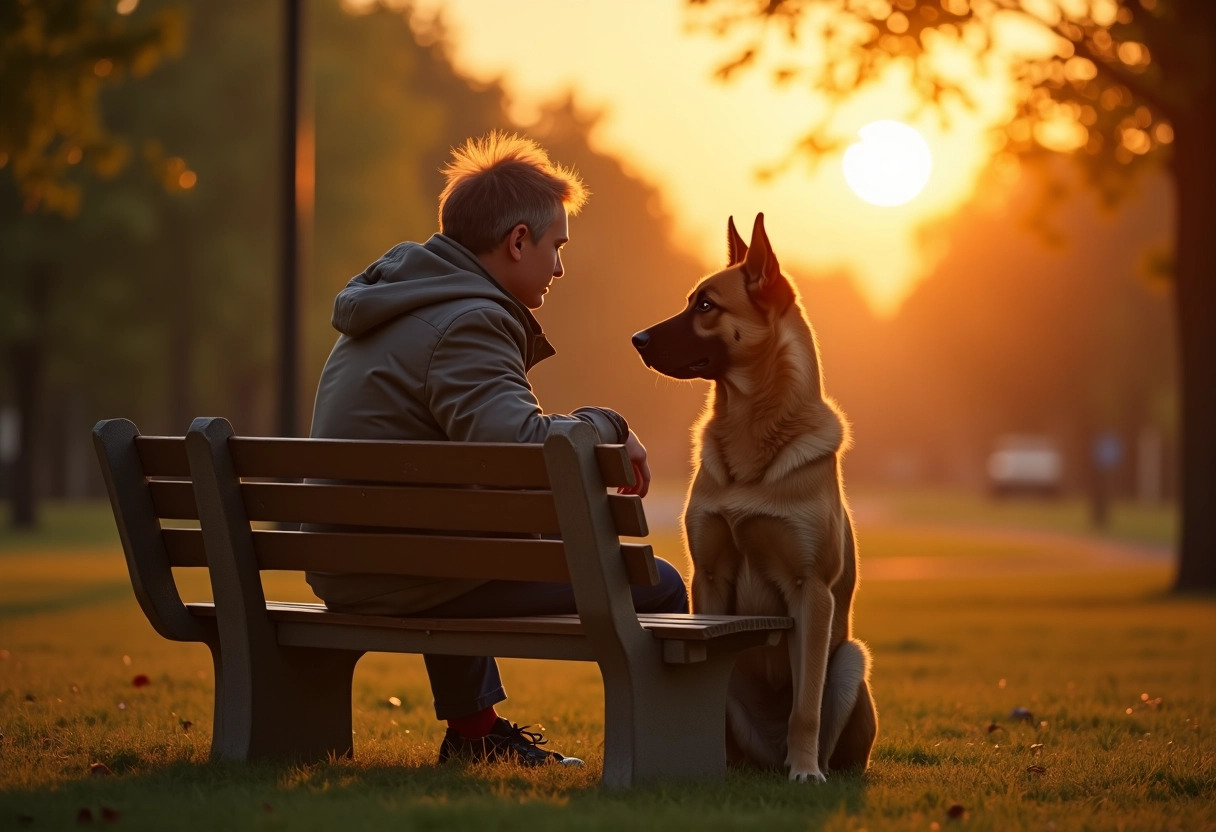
[413,558,688,719]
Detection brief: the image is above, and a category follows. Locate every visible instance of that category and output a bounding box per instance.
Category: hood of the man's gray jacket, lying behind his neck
[332,234,554,366]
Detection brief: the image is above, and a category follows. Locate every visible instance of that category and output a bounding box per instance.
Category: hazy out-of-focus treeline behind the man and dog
[0,0,1175,525]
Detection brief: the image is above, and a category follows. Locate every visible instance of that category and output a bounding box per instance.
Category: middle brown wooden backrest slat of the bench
[150,480,647,538]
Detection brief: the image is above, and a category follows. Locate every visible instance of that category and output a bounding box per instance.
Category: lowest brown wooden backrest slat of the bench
[164,529,658,586]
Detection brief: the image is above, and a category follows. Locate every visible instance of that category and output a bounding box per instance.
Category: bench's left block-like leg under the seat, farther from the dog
[212,647,362,761]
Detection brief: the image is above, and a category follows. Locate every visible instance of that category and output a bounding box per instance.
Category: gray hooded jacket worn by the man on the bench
[309,234,629,613]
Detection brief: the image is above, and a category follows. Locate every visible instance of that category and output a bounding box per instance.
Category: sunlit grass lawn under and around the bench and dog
[0,510,1216,832]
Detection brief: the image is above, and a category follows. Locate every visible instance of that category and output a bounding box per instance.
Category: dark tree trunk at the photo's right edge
[1172,111,1216,592]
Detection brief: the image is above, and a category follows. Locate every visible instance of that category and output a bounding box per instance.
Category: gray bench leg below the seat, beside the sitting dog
[601,651,736,788]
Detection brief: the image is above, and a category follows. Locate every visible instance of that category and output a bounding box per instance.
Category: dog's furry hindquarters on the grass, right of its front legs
[820,640,878,772]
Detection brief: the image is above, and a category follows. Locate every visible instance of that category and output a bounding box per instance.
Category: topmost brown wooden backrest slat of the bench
[135,437,634,489]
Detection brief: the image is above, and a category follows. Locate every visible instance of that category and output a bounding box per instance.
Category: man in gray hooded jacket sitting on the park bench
[309,133,688,765]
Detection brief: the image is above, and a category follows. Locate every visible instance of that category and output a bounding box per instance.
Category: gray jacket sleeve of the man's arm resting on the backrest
[426,307,629,443]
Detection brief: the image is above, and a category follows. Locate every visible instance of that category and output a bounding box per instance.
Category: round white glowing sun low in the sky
[841,120,933,208]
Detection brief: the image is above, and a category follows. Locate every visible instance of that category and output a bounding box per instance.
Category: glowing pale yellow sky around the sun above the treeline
[364,0,1050,311]
